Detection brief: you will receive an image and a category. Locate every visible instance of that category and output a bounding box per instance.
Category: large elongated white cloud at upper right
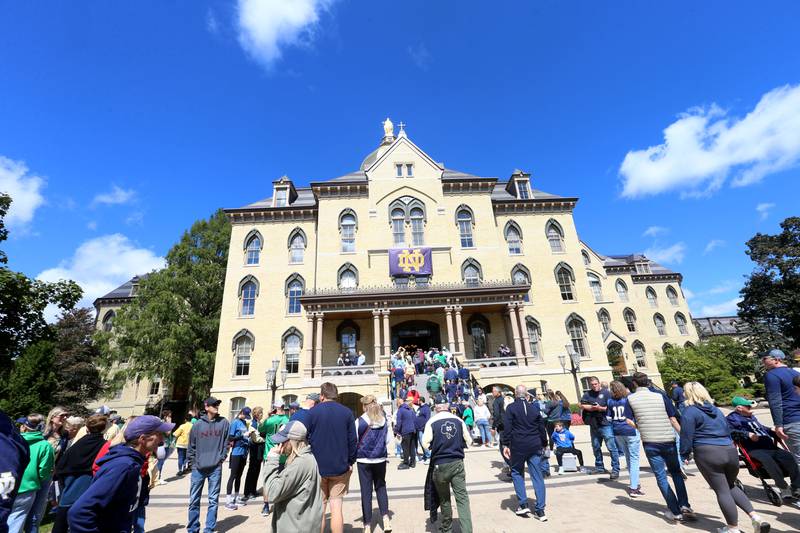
[619,85,800,198]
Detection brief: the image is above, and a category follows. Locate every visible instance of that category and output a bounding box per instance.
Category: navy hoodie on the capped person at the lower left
[67,445,144,533]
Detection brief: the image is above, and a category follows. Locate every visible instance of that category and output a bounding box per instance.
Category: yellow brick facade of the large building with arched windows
[212,122,697,409]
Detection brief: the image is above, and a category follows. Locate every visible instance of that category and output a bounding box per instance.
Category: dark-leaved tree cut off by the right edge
[739,217,800,353]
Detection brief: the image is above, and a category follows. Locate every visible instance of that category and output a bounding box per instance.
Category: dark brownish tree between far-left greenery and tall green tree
[50,307,103,412]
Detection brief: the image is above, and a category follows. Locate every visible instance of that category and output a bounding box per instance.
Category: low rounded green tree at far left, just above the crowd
[0,340,56,417]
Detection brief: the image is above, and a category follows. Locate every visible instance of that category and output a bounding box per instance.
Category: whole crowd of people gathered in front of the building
[0,350,800,533]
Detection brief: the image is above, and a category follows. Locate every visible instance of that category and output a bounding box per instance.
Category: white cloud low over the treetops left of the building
[37,233,164,312]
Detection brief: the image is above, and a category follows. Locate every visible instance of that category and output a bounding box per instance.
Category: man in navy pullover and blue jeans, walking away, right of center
[501,385,547,522]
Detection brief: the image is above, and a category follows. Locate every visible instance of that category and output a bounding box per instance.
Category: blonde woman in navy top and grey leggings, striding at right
[681,381,770,533]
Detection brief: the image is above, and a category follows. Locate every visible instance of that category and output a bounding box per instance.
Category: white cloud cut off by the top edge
[238,0,336,68]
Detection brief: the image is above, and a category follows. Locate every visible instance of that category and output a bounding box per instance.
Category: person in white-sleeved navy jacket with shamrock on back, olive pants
[422,394,472,533]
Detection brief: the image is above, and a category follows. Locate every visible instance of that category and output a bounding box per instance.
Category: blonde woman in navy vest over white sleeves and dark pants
[356,394,394,531]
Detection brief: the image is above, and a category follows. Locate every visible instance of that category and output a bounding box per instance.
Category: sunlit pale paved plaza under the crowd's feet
[141,410,800,533]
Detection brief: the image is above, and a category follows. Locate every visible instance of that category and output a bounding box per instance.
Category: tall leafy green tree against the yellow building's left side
[95,210,231,401]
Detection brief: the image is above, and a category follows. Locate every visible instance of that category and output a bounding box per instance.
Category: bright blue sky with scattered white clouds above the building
[0,0,800,316]
